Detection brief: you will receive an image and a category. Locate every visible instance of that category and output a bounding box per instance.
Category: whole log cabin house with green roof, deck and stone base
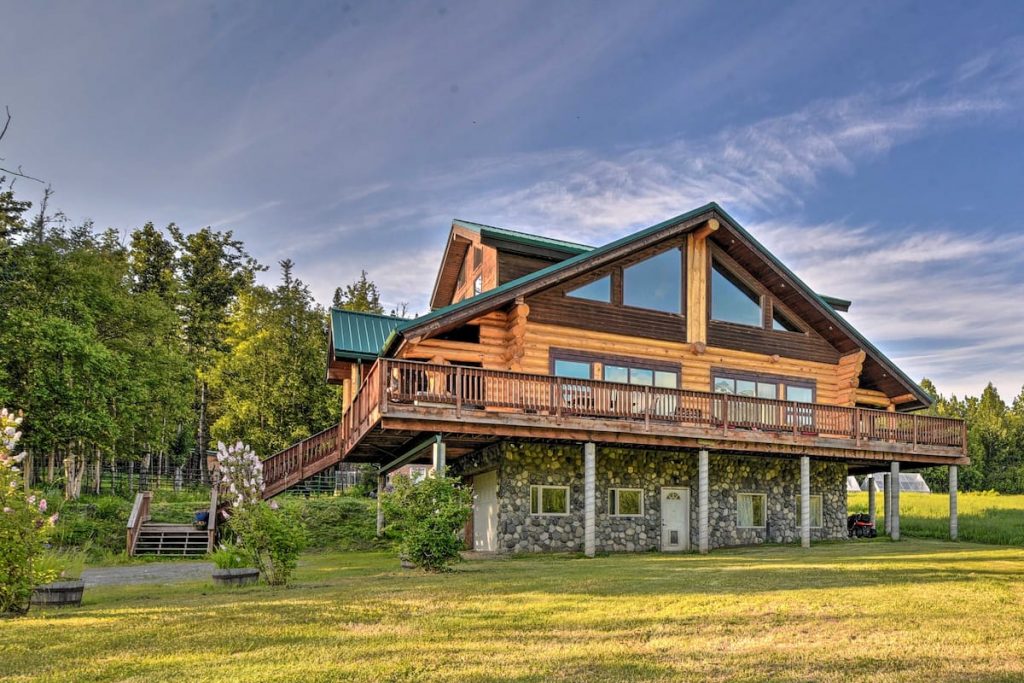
[264,204,968,554]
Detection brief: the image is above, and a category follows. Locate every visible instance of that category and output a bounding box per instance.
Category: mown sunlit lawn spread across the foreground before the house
[6,541,1024,681]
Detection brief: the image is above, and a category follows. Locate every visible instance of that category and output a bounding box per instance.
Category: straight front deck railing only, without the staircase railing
[378,359,965,450]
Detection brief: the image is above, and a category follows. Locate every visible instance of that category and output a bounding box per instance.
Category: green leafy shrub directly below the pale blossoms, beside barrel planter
[229,501,305,586]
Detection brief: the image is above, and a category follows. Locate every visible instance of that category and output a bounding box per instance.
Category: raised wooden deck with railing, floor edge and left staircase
[263,358,968,497]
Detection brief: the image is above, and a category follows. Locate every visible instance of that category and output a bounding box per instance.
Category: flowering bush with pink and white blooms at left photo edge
[0,409,57,614]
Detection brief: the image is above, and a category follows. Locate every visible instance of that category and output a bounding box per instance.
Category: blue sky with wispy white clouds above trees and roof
[0,0,1024,399]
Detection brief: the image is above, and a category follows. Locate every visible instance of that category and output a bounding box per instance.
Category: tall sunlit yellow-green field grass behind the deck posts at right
[848,492,1024,546]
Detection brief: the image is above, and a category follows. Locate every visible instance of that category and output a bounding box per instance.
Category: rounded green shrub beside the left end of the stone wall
[382,476,472,571]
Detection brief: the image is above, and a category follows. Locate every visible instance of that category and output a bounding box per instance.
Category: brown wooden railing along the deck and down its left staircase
[263,358,967,497]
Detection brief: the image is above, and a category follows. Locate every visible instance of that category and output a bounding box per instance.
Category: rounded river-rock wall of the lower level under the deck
[449,442,847,553]
